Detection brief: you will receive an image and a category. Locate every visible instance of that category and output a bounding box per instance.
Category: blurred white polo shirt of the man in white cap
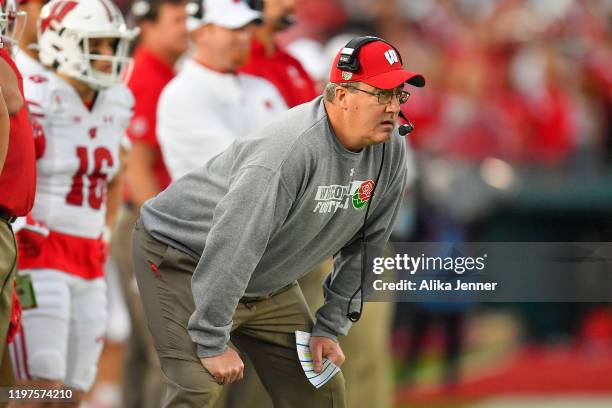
[157,59,287,180]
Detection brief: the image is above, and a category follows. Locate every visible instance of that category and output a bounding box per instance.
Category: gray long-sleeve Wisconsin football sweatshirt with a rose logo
[141,97,406,357]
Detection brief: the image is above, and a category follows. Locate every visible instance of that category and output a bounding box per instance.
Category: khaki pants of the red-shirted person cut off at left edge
[0,218,17,382]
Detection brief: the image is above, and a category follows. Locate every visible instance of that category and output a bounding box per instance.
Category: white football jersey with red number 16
[24,74,134,238]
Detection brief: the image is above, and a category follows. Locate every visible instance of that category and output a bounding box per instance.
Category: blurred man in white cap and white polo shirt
[157,0,287,179]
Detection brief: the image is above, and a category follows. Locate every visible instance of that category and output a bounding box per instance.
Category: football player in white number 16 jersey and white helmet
[11,0,137,405]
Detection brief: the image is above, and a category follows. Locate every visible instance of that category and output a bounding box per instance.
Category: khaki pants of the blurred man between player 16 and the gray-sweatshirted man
[111,206,165,408]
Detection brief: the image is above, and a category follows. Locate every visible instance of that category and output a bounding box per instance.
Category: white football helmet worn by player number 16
[38,0,139,89]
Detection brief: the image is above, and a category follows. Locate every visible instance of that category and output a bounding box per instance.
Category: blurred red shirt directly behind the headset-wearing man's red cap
[240,39,319,108]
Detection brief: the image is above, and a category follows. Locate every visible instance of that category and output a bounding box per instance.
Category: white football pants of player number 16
[9,269,107,391]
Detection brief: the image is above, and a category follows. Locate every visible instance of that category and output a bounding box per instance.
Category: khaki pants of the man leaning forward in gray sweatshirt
[133,222,346,408]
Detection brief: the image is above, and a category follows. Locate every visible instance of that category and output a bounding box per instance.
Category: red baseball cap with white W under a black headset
[329,41,425,89]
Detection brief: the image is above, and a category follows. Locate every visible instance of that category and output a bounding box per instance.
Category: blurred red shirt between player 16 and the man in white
[127,46,175,197]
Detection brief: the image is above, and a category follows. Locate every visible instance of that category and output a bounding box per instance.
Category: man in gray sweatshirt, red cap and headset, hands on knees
[133,37,425,407]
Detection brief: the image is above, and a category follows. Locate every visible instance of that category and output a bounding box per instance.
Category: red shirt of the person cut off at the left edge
[0,49,36,217]
